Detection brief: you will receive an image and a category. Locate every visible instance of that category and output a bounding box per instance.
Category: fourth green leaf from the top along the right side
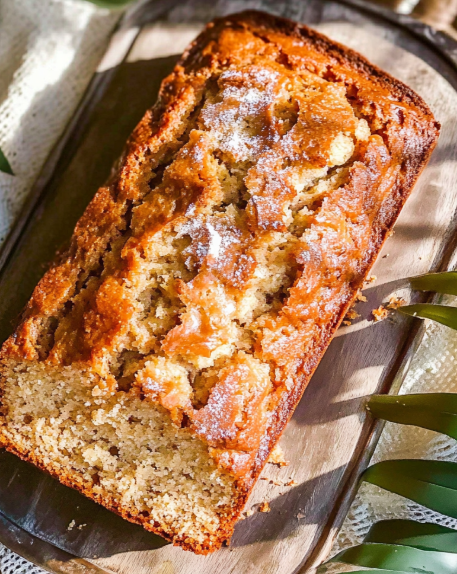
[362,460,457,518]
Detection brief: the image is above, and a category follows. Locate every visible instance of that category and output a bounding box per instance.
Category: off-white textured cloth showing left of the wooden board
[0,0,119,574]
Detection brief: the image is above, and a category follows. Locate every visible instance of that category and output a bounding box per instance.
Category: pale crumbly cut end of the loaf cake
[0,362,241,553]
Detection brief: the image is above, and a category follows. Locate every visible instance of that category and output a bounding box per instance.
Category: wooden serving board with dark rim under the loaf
[0,0,457,574]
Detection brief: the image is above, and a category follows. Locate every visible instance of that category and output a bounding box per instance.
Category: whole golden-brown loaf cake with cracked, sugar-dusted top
[0,12,439,553]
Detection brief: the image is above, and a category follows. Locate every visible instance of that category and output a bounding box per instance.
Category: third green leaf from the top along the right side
[367,393,457,440]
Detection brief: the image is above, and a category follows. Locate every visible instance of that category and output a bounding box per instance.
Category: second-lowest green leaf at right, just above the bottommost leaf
[364,520,457,554]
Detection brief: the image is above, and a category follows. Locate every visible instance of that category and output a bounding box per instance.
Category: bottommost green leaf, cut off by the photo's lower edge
[330,543,457,574]
